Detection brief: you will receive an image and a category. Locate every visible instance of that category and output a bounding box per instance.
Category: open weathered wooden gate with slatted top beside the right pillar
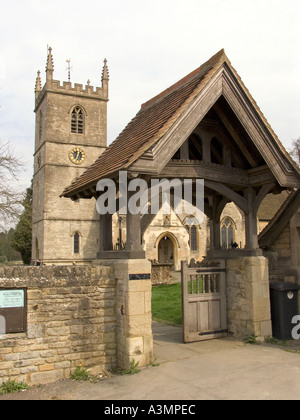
[181,261,228,343]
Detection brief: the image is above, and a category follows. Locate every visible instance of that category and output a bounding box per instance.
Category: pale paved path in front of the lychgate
[0,322,300,402]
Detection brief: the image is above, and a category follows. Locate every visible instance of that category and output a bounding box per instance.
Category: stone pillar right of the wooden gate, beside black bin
[226,256,272,338]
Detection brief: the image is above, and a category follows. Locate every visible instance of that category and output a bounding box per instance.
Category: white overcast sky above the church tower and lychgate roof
[0,0,300,186]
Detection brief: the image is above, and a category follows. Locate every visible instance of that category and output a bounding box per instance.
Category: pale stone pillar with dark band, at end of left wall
[101,259,153,369]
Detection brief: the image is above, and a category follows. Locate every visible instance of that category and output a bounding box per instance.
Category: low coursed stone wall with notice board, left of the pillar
[0,266,116,384]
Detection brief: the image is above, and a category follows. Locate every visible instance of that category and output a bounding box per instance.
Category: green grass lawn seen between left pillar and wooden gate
[152,283,182,325]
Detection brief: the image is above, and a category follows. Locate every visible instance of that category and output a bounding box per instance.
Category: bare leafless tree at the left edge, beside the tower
[0,141,24,230]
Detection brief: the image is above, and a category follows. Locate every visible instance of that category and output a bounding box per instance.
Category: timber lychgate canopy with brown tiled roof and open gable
[63,50,300,256]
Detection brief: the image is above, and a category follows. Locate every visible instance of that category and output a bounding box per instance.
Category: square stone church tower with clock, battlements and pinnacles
[32,48,109,264]
